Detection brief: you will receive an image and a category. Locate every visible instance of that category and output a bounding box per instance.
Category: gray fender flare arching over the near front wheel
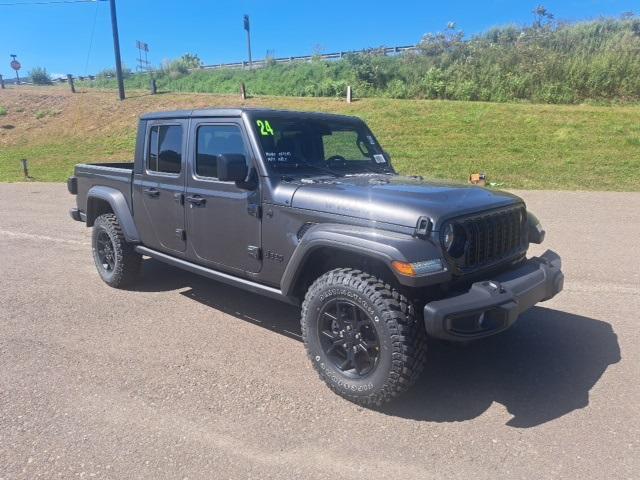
[280,223,448,296]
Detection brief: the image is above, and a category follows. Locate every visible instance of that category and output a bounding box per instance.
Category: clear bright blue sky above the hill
[0,0,640,77]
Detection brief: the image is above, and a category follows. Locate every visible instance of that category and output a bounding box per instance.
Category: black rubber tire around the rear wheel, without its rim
[91,213,142,288]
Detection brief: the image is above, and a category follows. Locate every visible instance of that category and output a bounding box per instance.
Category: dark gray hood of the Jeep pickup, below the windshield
[291,175,522,230]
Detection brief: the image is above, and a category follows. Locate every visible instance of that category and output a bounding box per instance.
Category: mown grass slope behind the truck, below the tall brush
[0,87,640,191]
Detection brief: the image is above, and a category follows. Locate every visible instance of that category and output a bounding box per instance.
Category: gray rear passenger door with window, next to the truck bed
[133,120,189,253]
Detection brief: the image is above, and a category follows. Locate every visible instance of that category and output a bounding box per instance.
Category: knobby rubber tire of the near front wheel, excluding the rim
[301,268,426,406]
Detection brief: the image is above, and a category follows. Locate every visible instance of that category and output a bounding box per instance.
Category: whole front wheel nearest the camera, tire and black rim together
[301,268,426,405]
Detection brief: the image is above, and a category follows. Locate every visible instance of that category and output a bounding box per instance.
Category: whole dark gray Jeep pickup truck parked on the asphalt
[68,109,564,405]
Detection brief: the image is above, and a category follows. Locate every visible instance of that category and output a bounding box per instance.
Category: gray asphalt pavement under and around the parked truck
[0,183,640,480]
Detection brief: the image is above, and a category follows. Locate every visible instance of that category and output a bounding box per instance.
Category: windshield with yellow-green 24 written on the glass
[252,114,393,176]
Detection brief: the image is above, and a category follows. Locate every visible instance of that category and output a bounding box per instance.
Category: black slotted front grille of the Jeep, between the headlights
[440,204,529,275]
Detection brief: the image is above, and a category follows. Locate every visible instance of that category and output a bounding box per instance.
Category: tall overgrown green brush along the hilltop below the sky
[85,17,640,104]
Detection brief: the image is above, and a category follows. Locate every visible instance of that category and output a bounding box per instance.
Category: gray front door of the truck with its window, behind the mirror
[185,119,262,273]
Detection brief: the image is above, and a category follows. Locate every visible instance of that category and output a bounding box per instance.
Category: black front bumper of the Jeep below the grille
[424,250,564,341]
